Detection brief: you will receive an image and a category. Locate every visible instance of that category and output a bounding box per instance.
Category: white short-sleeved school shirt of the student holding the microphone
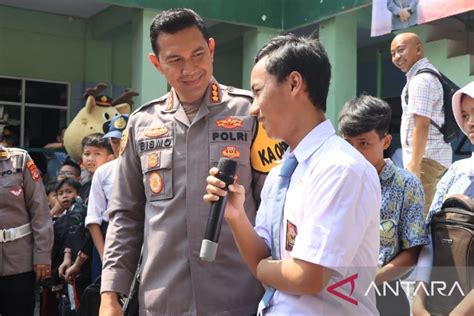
[255,120,381,315]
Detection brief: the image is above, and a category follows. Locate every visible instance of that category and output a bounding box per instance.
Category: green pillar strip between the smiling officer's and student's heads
[242,28,280,89]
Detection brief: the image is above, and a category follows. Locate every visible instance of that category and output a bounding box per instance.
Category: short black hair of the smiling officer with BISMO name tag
[150,8,209,56]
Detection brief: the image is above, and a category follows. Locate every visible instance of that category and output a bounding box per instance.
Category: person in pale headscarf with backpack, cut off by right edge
[412,82,474,316]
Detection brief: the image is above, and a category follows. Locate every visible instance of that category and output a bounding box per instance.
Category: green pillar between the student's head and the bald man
[319,12,357,126]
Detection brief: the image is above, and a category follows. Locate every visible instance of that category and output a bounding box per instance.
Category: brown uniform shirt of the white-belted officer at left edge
[0,144,53,276]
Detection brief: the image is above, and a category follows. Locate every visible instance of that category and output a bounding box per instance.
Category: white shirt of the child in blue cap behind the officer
[86,159,118,226]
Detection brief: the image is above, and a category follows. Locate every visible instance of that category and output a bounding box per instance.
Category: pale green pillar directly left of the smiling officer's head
[131,9,168,108]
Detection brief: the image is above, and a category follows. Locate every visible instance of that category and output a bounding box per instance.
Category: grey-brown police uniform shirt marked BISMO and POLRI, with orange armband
[101,81,286,315]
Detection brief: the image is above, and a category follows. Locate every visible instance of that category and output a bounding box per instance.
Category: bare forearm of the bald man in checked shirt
[407,114,430,178]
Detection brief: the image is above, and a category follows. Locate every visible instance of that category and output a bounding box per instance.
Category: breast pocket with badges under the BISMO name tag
[141,148,173,202]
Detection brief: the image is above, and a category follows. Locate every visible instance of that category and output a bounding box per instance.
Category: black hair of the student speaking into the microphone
[255,33,331,112]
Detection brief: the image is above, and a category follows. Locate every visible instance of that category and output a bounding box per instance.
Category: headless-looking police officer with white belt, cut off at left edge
[0,144,53,316]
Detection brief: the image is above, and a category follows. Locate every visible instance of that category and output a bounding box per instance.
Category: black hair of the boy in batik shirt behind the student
[338,95,392,139]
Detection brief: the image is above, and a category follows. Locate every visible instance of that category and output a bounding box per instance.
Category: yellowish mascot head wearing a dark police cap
[64,83,138,161]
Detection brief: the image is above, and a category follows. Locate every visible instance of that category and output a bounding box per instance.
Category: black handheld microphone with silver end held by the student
[199,158,237,262]
